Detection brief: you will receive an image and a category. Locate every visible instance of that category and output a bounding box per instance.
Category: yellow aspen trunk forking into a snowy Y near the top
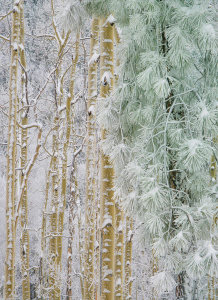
[49,8,70,299]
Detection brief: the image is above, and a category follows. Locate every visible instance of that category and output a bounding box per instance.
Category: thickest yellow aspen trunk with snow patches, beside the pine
[99,17,115,300]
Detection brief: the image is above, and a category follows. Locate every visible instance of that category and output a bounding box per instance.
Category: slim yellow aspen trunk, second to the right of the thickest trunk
[124,216,133,299]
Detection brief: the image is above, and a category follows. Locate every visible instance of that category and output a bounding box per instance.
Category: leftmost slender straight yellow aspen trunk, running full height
[4,1,20,299]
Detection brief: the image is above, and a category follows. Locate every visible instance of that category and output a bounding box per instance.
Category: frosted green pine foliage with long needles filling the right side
[86,0,218,299]
